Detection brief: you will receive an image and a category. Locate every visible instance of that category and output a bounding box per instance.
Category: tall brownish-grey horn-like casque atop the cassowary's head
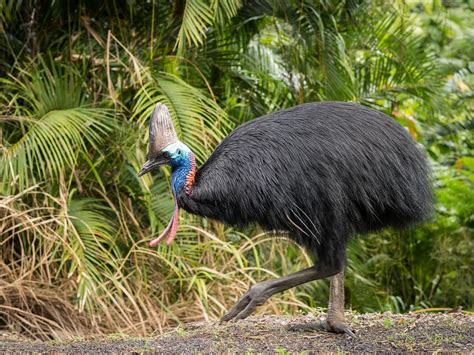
[148,103,178,154]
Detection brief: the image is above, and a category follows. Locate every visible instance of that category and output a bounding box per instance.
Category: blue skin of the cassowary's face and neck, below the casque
[162,142,192,196]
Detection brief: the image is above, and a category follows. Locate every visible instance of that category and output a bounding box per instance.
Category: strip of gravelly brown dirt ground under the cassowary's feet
[0,313,474,354]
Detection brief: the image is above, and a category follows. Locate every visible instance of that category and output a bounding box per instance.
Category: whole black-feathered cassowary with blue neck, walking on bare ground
[139,102,432,335]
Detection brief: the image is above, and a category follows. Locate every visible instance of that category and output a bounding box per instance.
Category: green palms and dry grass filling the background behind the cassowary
[0,0,474,338]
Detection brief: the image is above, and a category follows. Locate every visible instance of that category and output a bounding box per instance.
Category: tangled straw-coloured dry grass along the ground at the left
[0,186,309,340]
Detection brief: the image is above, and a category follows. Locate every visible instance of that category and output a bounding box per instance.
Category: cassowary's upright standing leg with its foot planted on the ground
[290,271,355,337]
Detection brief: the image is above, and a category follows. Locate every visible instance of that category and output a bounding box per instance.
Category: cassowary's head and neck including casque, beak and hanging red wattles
[138,103,195,246]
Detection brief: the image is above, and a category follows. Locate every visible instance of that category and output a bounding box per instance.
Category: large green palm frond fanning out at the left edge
[0,62,114,189]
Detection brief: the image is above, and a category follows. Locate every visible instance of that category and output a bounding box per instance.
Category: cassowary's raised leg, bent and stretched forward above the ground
[221,265,338,322]
